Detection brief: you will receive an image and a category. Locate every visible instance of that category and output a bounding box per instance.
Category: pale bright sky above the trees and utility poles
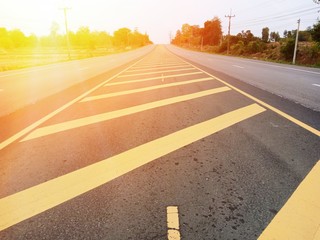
[0,0,320,43]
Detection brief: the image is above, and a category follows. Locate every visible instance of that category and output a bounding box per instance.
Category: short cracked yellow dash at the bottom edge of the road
[167,206,181,240]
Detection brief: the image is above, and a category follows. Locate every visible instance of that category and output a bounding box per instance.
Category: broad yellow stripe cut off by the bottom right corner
[259,160,320,240]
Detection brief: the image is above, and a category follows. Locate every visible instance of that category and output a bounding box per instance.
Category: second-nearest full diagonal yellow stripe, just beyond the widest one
[21,87,230,141]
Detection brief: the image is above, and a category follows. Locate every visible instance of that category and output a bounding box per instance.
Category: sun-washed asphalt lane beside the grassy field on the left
[0,45,154,116]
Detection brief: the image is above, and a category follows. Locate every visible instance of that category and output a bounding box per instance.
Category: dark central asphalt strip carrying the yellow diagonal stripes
[0,46,320,239]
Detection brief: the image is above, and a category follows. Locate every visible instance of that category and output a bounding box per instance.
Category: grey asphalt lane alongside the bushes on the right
[167,45,320,112]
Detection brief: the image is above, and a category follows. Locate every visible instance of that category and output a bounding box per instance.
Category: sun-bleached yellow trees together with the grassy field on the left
[0,26,152,71]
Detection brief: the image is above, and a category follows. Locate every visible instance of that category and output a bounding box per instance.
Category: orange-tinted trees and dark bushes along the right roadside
[171,17,320,67]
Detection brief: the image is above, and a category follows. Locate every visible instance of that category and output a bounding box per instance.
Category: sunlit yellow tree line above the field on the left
[0,23,152,49]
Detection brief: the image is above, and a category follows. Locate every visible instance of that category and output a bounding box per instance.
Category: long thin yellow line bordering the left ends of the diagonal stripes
[0,56,148,150]
